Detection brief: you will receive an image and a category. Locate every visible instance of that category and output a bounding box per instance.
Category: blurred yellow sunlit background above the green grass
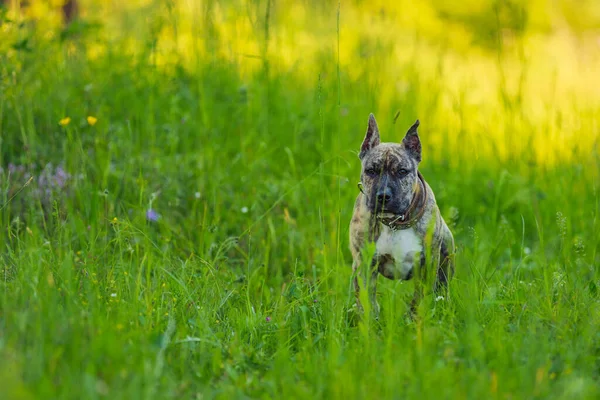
[5,0,600,164]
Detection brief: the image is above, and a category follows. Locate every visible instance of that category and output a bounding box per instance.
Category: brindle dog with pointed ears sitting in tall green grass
[350,114,455,319]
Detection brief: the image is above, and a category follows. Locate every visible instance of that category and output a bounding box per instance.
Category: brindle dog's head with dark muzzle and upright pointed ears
[359,114,421,215]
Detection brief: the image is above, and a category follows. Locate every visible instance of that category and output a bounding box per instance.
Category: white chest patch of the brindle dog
[375,225,423,279]
